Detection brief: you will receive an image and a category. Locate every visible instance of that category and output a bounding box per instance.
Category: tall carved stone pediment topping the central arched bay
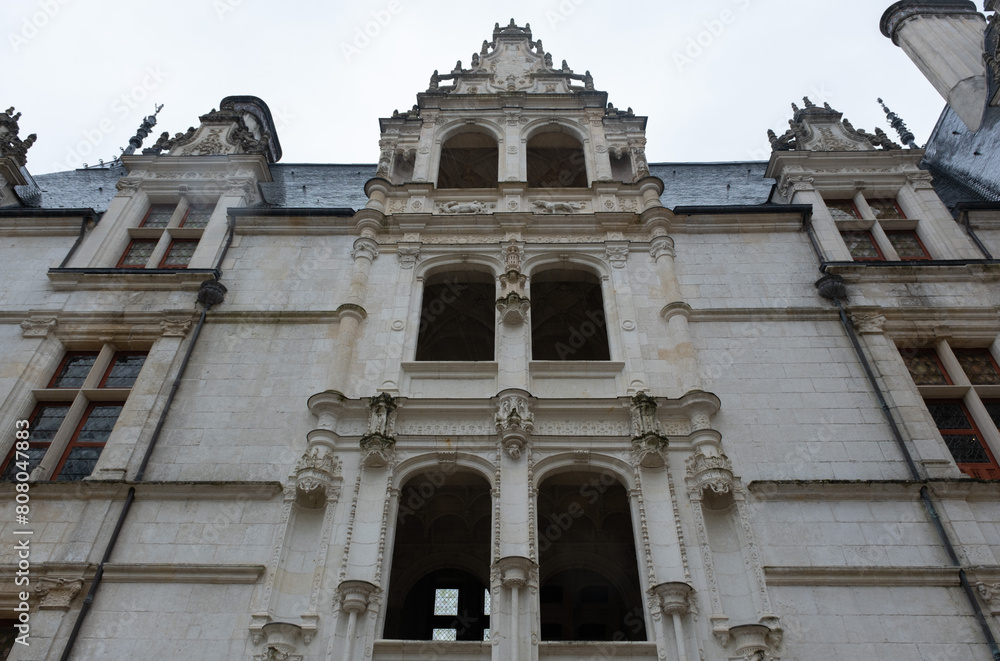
[427,19,594,94]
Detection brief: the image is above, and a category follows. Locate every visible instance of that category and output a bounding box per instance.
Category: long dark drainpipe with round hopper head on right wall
[816,275,1000,661]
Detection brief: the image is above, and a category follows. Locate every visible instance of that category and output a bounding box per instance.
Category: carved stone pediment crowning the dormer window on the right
[767,97,901,151]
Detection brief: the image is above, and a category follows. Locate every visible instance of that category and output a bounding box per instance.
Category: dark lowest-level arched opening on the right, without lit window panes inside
[538,473,646,641]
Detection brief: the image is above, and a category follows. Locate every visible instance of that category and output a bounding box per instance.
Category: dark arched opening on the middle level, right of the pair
[531,270,611,360]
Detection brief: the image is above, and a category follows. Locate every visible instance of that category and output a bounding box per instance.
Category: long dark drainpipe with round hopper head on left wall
[59,280,226,661]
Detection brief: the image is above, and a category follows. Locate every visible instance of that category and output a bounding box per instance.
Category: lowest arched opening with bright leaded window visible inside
[384,470,492,641]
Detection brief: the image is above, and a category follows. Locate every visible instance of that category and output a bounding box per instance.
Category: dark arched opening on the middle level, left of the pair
[416,271,496,361]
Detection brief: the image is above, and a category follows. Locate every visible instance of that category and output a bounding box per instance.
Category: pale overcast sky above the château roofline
[0,0,960,174]
